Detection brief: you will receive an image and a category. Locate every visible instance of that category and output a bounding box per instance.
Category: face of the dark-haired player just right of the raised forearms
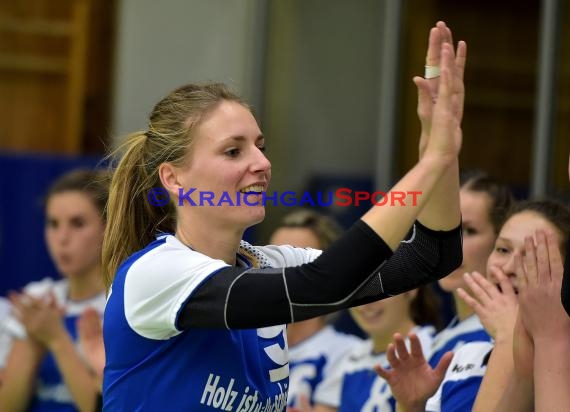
[439,189,495,292]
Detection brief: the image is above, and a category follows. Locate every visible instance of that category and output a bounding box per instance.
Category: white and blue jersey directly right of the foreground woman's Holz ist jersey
[287,325,362,406]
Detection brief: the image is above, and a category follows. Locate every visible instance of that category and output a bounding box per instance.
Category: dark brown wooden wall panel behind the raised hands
[400,0,539,193]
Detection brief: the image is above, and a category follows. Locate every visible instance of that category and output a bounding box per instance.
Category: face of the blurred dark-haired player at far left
[45,191,105,277]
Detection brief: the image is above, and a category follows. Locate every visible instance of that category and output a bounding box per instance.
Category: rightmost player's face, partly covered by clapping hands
[487,211,561,290]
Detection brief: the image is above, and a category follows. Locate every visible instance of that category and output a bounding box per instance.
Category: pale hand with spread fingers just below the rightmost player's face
[457,267,518,340]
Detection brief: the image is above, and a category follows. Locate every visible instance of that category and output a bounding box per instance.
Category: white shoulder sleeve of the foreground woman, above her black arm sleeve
[124,242,229,340]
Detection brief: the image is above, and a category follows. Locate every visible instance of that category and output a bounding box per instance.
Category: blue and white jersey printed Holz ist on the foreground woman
[103,235,321,412]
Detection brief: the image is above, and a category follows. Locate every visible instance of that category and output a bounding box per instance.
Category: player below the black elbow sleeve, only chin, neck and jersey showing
[314,286,439,412]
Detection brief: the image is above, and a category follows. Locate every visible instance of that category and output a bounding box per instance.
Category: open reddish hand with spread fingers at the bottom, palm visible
[374,333,453,410]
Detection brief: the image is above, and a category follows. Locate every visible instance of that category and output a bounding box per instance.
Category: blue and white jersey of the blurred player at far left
[6,278,105,412]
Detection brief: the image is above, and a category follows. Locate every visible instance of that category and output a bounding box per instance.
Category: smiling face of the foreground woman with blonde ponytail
[174,100,271,229]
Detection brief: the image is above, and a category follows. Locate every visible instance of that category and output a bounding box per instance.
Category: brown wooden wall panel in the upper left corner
[0,0,114,154]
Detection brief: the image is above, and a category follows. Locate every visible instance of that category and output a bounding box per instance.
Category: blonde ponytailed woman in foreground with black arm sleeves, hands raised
[103,20,466,411]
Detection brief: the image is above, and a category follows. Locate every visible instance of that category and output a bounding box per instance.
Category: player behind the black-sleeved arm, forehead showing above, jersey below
[269,209,361,406]
